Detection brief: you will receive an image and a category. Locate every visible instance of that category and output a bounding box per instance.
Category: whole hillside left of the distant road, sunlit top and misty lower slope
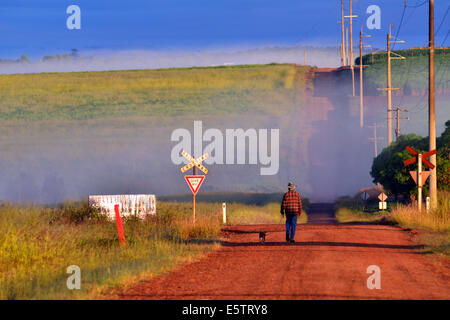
[0,64,320,203]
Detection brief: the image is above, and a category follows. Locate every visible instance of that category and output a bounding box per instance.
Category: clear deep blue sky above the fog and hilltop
[0,0,450,58]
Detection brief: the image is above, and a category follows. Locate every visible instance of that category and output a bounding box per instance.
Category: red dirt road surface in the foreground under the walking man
[113,205,450,300]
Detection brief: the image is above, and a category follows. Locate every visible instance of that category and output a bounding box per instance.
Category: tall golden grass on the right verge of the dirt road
[392,191,450,257]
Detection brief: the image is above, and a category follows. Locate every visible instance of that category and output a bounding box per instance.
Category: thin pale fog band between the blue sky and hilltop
[0,47,340,74]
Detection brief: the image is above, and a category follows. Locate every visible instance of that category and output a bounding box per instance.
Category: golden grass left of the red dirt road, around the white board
[0,198,306,299]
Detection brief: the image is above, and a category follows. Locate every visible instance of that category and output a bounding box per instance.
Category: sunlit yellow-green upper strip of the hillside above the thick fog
[0,64,310,120]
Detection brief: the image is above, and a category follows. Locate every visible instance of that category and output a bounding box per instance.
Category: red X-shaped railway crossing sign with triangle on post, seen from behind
[403,146,437,212]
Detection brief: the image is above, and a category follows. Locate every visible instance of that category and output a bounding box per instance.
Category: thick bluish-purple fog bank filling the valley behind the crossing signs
[0,52,449,203]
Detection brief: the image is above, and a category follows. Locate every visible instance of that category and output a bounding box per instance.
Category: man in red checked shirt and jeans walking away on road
[281,182,302,243]
